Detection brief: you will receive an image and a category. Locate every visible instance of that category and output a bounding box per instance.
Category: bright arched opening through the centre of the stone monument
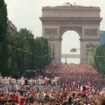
[61,30,80,64]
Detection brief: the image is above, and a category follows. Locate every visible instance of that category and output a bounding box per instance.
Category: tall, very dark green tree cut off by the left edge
[0,0,8,75]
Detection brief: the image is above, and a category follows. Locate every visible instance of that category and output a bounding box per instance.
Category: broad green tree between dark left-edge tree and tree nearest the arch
[8,29,34,76]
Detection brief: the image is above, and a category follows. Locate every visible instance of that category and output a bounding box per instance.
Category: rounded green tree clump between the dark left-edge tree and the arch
[8,29,51,76]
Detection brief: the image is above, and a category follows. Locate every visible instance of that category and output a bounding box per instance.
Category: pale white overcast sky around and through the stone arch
[5,0,105,63]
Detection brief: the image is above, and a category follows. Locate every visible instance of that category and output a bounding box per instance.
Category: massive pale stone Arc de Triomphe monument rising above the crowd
[40,4,101,64]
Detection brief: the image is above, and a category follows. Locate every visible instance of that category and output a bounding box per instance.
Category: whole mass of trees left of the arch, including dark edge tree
[0,0,51,76]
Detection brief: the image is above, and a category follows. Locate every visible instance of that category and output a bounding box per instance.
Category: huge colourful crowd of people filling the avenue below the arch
[0,65,105,105]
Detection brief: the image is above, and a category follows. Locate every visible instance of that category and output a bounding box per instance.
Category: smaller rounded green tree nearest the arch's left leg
[32,37,52,69]
